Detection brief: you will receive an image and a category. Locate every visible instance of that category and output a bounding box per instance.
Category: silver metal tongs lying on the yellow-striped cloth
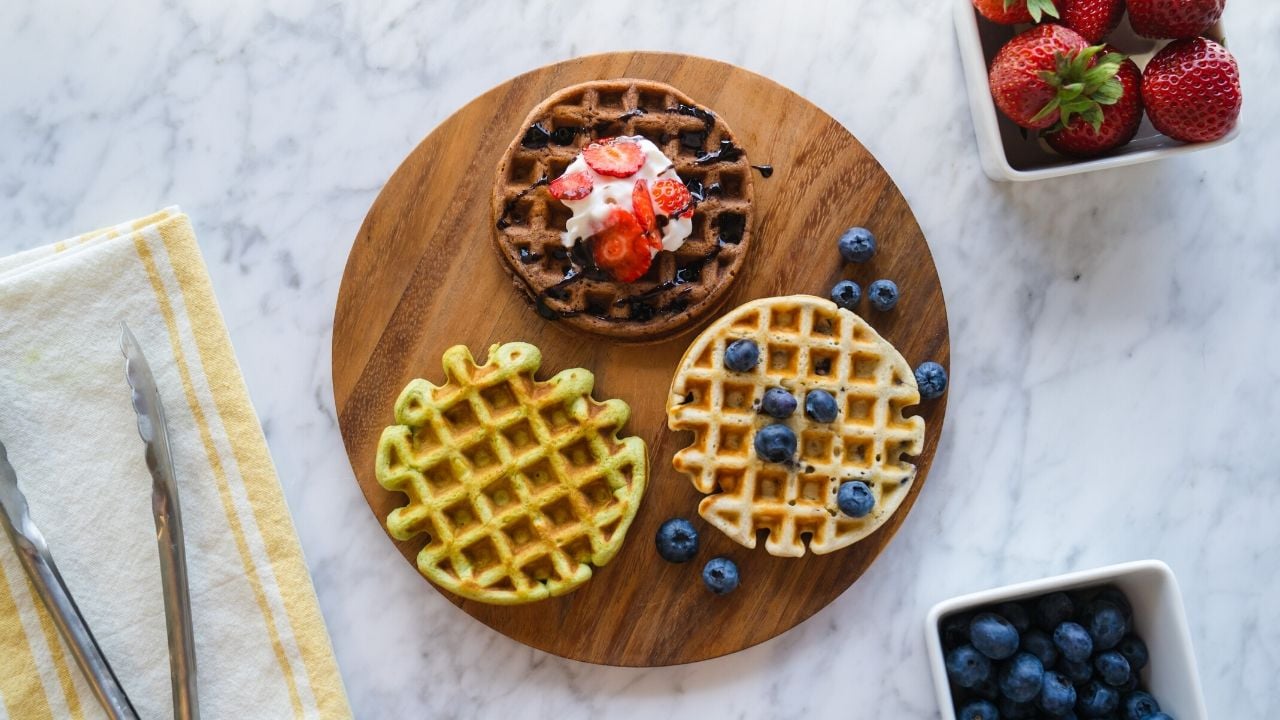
[0,323,200,720]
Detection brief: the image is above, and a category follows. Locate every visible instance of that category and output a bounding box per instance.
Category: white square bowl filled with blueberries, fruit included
[925,560,1208,720]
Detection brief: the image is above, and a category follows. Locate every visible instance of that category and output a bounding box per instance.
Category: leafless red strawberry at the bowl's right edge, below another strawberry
[1142,37,1242,142]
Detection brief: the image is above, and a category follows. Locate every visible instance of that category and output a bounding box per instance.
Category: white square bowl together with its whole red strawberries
[954,0,1242,181]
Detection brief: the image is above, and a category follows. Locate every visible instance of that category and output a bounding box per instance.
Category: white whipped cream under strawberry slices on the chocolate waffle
[561,136,694,254]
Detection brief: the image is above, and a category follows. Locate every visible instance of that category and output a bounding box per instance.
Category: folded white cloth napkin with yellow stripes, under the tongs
[0,208,351,720]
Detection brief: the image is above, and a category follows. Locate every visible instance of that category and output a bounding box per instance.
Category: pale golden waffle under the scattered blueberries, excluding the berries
[667,296,924,556]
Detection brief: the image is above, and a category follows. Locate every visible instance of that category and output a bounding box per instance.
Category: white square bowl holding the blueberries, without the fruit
[924,560,1208,720]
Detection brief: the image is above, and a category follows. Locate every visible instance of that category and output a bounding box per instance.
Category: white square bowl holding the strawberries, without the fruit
[952,0,1240,182]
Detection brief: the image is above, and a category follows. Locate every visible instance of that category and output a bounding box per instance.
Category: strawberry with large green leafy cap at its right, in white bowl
[988,24,1121,129]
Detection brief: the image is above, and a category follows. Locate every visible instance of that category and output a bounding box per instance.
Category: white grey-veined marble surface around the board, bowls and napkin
[0,0,1280,719]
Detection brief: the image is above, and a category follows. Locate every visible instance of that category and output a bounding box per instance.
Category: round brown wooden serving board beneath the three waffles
[333,53,950,666]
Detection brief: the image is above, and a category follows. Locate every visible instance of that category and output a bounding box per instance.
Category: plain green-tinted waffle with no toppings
[378,342,646,605]
